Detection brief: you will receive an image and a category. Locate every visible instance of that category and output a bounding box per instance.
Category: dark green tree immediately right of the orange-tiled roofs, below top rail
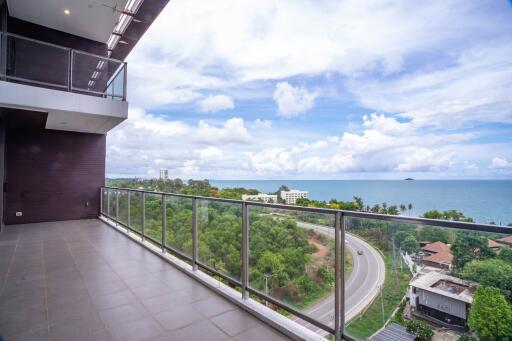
[451,232,494,271]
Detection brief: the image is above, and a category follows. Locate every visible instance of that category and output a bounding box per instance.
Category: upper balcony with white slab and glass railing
[0,33,128,133]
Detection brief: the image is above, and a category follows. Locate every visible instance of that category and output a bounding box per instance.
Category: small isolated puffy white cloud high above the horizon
[273,82,318,118]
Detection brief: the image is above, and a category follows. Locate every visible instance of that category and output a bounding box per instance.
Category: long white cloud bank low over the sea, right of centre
[245,114,471,175]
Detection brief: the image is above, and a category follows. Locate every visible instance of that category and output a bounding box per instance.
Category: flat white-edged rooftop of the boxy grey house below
[410,272,477,304]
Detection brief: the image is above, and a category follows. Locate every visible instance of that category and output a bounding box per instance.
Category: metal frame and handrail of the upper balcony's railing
[0,32,127,101]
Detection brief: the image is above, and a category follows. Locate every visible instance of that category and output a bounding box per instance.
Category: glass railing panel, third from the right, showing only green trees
[197,199,242,282]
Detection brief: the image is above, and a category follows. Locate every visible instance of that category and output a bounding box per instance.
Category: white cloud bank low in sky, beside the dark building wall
[107,109,252,178]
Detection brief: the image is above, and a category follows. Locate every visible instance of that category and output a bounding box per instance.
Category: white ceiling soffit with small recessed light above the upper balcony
[7,0,127,43]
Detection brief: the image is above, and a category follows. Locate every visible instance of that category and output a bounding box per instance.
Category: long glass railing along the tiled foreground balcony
[101,187,512,340]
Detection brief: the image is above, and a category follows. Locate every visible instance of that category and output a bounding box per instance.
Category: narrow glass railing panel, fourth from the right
[165,196,192,257]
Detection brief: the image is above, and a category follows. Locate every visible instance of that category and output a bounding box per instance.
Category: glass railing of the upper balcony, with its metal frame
[0,33,127,100]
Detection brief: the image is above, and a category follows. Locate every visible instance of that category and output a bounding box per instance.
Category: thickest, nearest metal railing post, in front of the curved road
[334,212,345,341]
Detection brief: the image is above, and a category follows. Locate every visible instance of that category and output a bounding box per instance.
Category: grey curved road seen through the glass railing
[292,221,386,334]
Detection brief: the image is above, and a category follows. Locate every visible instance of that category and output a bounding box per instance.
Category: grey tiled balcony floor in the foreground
[0,220,287,341]
